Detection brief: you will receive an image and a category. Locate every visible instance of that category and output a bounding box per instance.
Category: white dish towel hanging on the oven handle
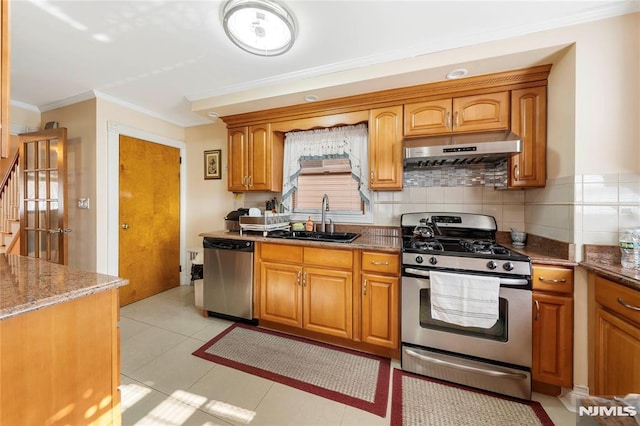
[429,271,500,328]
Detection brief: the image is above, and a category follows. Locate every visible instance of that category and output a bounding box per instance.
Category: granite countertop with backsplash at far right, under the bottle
[580,244,640,291]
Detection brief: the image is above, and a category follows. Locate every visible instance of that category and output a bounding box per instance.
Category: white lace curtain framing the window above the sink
[282,124,371,211]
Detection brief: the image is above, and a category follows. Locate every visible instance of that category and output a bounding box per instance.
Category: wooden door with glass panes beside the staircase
[19,128,71,265]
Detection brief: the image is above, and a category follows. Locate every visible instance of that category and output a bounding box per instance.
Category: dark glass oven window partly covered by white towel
[420,288,508,342]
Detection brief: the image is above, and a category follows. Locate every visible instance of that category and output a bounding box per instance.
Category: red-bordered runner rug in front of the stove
[391,369,553,426]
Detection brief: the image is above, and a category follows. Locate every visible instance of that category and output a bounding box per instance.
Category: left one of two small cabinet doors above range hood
[404,98,451,136]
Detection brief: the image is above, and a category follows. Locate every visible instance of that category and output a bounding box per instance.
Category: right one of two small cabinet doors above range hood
[453,91,509,132]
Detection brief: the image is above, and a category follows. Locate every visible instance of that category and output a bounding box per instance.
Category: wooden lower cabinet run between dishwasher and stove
[256,243,400,356]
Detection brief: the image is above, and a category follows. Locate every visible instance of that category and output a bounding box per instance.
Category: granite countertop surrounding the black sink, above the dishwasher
[199,226,402,253]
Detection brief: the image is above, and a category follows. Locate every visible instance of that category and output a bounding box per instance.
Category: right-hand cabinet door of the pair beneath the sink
[302,267,353,339]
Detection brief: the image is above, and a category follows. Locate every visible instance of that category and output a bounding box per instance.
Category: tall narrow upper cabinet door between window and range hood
[369,105,403,190]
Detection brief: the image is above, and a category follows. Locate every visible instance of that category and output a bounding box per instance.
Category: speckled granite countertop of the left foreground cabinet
[0,254,129,320]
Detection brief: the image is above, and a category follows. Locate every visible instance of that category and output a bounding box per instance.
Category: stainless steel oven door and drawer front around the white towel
[401,267,532,399]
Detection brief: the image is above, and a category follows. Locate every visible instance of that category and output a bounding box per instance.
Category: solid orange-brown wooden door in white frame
[118,136,180,306]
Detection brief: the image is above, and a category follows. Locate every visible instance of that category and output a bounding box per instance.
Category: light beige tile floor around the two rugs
[120,286,576,426]
